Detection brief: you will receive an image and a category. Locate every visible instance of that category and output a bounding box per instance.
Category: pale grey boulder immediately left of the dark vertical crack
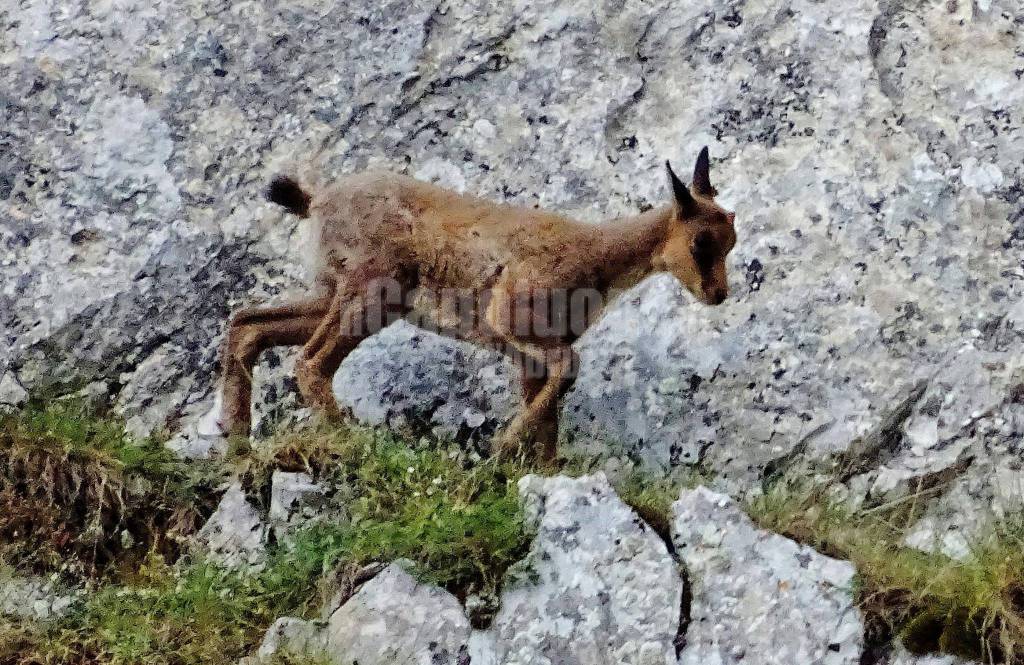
[489,473,683,665]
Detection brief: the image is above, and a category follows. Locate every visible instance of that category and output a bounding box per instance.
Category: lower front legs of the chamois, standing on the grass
[496,341,578,460]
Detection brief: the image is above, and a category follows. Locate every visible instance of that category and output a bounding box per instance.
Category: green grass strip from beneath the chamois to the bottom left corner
[6,420,530,665]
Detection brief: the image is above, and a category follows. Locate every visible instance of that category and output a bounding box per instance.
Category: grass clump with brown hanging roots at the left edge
[0,402,220,581]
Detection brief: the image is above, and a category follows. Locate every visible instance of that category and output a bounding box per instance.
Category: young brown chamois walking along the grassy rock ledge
[221,148,736,458]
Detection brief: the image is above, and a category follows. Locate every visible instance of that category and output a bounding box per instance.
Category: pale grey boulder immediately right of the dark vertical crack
[672,487,863,665]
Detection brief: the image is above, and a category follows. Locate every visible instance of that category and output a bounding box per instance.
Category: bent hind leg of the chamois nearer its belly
[296,276,401,419]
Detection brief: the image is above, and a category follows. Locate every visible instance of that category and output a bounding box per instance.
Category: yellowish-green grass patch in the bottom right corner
[748,480,1024,664]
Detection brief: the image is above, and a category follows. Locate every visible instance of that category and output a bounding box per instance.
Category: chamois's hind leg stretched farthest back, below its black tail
[220,296,331,435]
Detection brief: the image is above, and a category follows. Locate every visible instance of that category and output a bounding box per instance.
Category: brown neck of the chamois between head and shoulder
[597,206,672,289]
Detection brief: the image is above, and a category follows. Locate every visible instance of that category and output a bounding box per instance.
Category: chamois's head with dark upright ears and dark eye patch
[655,147,736,304]
